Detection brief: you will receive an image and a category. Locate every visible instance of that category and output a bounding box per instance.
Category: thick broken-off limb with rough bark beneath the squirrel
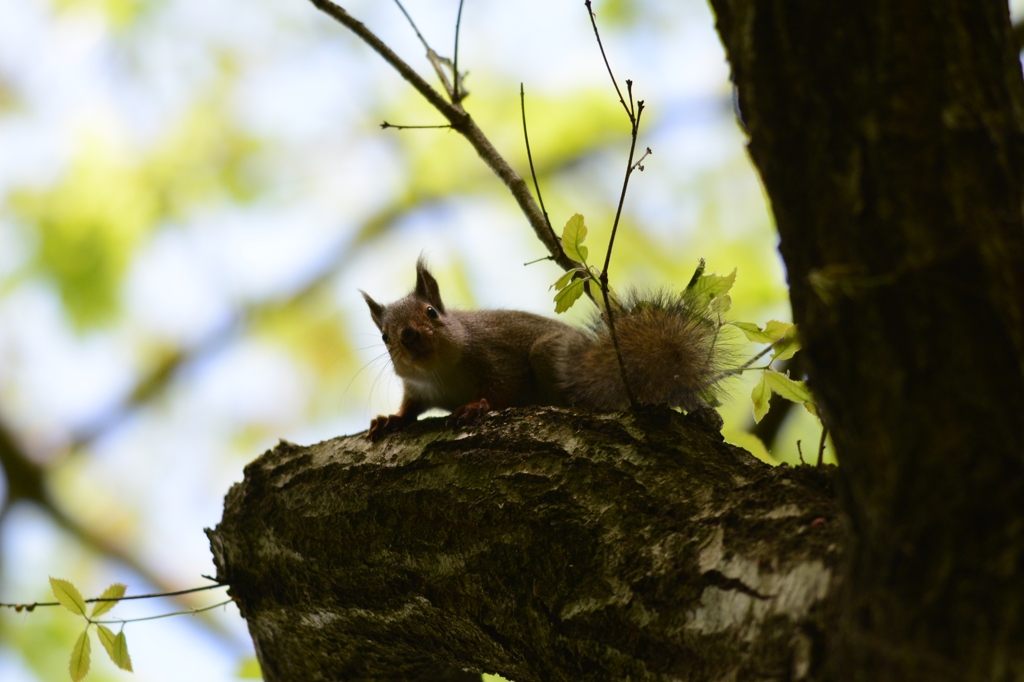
[208,408,841,682]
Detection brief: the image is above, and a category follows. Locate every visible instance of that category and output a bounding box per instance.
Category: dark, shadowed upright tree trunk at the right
[712,0,1024,681]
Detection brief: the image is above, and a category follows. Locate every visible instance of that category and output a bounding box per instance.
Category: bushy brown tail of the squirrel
[559,292,735,411]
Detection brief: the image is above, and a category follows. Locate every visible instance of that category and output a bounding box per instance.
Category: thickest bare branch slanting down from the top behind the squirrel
[310,0,574,270]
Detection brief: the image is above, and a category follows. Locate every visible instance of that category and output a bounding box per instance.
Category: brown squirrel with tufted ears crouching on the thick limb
[359,257,728,440]
